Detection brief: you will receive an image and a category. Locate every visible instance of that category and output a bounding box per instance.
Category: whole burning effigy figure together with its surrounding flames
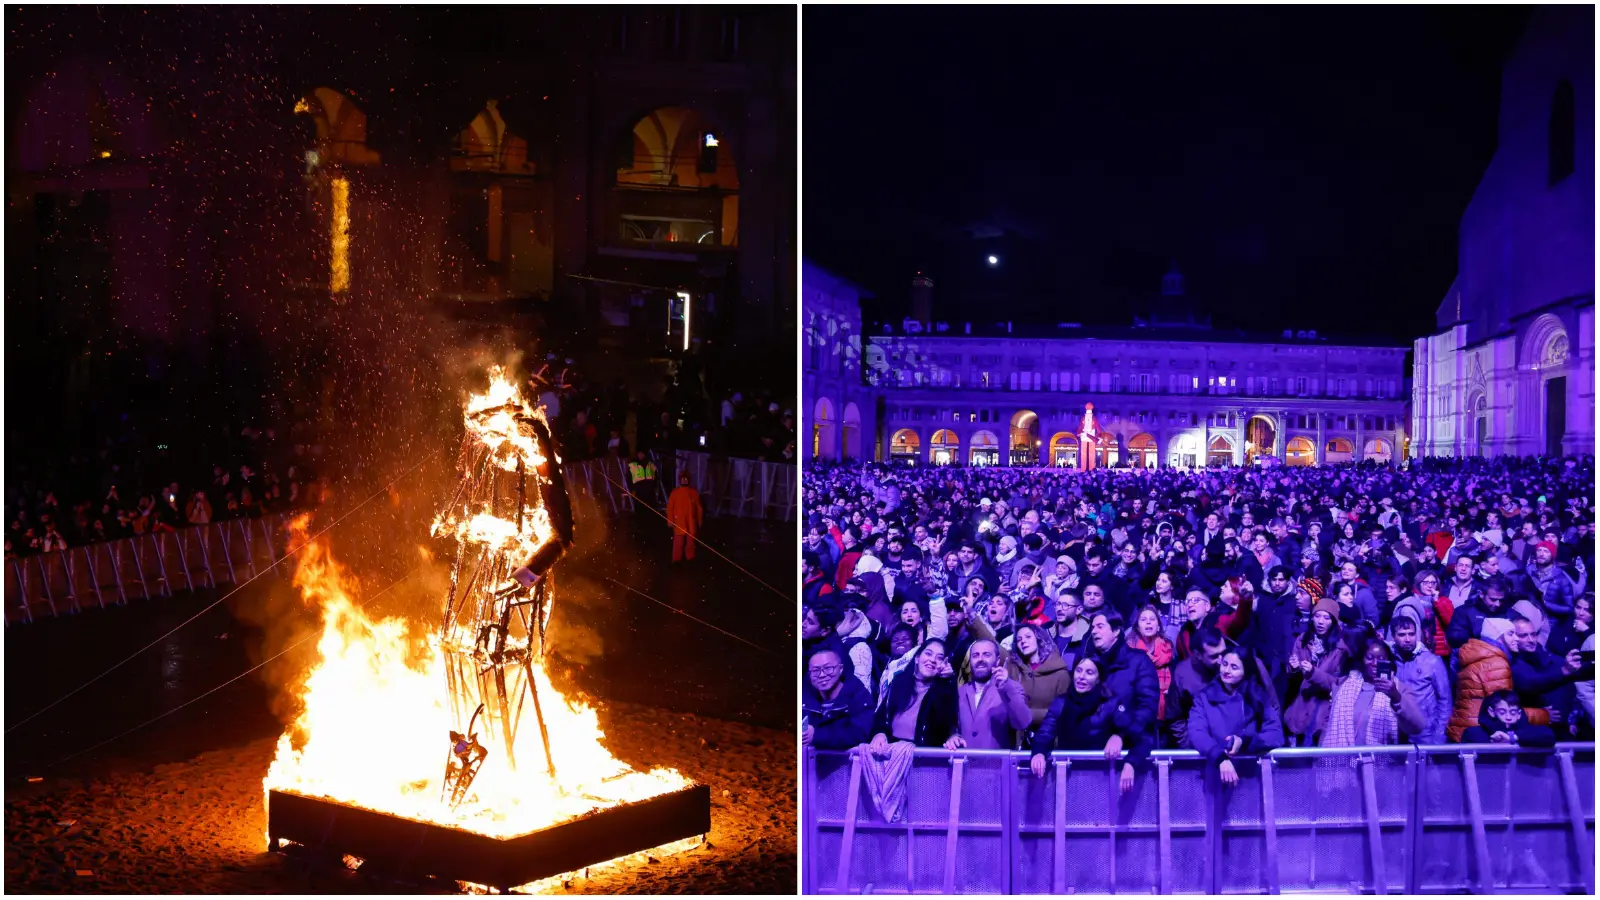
[266,361,688,838]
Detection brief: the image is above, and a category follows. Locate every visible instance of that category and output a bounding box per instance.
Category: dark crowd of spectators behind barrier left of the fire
[5,416,326,559]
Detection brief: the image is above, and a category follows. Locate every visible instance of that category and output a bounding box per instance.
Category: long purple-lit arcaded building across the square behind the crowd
[802,264,1406,468]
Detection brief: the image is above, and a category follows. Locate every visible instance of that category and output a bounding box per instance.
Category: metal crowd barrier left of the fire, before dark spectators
[5,514,288,625]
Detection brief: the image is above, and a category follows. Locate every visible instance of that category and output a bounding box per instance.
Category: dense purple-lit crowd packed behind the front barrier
[802,456,1595,790]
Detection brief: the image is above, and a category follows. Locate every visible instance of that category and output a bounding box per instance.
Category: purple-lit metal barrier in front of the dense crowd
[802,743,1595,895]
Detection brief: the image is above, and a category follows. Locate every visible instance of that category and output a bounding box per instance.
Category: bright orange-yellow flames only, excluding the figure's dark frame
[266,370,688,838]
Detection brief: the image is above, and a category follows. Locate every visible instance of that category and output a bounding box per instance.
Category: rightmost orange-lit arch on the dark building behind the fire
[613,106,739,247]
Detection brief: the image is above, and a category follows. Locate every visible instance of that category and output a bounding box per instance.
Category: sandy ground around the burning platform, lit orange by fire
[5,703,797,894]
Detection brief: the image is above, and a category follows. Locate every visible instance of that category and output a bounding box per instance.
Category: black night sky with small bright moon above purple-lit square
[802,6,1530,343]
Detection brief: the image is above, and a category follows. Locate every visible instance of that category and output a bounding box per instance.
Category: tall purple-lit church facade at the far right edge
[1411,6,1595,456]
